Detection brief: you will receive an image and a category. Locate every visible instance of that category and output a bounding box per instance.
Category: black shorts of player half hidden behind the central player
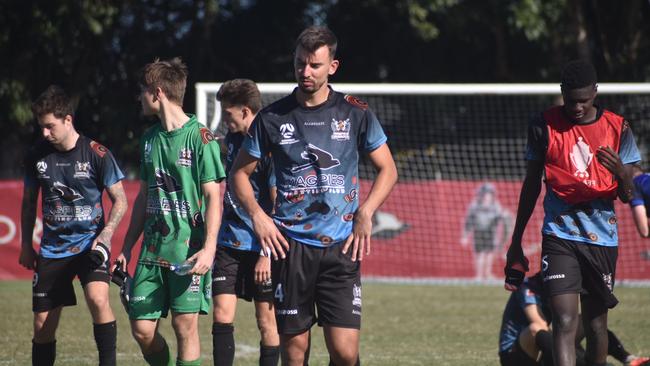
[212,246,273,302]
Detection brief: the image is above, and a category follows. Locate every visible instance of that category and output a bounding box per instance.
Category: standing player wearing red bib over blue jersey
[506,60,640,366]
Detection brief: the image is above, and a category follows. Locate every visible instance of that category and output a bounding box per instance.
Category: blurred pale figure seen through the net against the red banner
[460,183,512,281]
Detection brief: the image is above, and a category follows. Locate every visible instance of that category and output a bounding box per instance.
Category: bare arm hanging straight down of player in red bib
[505,160,544,291]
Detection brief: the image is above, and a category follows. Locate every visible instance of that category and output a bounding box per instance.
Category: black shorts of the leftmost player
[32,251,111,312]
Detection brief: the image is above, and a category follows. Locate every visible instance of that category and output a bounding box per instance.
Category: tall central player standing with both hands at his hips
[231,26,397,366]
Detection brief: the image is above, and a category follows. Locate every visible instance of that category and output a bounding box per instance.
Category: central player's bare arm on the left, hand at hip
[228,149,289,259]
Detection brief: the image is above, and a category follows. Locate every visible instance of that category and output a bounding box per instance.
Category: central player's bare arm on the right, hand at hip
[342,144,397,261]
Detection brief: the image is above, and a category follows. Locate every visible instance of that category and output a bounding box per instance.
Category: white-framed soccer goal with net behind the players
[196,83,650,284]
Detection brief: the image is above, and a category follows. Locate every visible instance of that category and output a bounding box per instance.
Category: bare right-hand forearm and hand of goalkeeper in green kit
[189,181,221,275]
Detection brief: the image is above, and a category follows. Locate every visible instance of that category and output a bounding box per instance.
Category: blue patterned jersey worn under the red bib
[526,109,641,247]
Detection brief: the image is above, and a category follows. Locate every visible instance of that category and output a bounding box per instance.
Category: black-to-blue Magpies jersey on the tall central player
[243,89,386,247]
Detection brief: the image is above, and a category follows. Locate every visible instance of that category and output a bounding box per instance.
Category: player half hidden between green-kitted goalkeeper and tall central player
[212,79,280,366]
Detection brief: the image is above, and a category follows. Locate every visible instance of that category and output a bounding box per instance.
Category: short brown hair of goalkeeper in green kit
[139,57,187,106]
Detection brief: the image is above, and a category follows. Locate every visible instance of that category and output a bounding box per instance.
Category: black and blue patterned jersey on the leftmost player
[24,136,124,258]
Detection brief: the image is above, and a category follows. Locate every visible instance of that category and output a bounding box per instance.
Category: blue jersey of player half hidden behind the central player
[217,133,275,252]
